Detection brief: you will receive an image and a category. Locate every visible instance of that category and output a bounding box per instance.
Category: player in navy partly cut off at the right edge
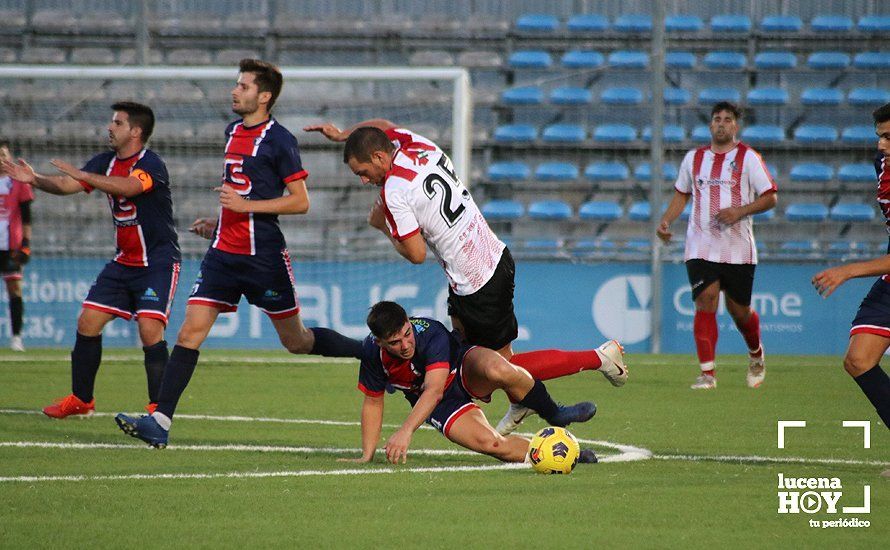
[813,103,890,436]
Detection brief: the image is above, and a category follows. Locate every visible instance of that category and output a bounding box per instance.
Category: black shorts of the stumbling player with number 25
[448,248,519,350]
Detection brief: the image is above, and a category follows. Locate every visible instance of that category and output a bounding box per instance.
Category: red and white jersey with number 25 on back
[380,128,506,296]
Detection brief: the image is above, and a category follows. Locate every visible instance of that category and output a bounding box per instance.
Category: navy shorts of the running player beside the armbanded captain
[188,248,300,319]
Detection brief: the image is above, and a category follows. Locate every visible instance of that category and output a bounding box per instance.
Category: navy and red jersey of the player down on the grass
[358,317,468,405]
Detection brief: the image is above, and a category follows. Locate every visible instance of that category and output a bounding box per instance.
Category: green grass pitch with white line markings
[0,350,890,548]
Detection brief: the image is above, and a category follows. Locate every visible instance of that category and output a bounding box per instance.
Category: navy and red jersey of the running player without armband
[211,118,309,256]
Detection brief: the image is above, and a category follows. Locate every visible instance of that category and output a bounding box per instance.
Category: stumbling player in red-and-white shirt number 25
[304,119,627,435]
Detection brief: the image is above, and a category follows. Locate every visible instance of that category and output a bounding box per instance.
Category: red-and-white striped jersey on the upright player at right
[674,143,777,264]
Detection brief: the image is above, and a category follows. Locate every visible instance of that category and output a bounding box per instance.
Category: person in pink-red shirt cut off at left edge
[0,140,34,351]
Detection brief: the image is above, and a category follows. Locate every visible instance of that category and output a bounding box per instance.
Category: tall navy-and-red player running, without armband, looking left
[115,59,361,448]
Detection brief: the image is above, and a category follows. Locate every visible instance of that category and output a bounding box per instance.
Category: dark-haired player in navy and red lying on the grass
[340,302,596,464]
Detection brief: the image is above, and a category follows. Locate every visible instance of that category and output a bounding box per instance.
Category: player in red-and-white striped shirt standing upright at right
[657,102,778,389]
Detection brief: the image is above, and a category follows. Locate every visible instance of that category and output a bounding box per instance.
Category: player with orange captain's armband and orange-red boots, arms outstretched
[4,101,180,418]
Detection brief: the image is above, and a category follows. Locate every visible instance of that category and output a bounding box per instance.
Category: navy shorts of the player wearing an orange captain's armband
[83,262,179,326]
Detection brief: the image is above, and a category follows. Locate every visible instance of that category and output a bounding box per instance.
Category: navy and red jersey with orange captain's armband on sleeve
[80,149,180,267]
